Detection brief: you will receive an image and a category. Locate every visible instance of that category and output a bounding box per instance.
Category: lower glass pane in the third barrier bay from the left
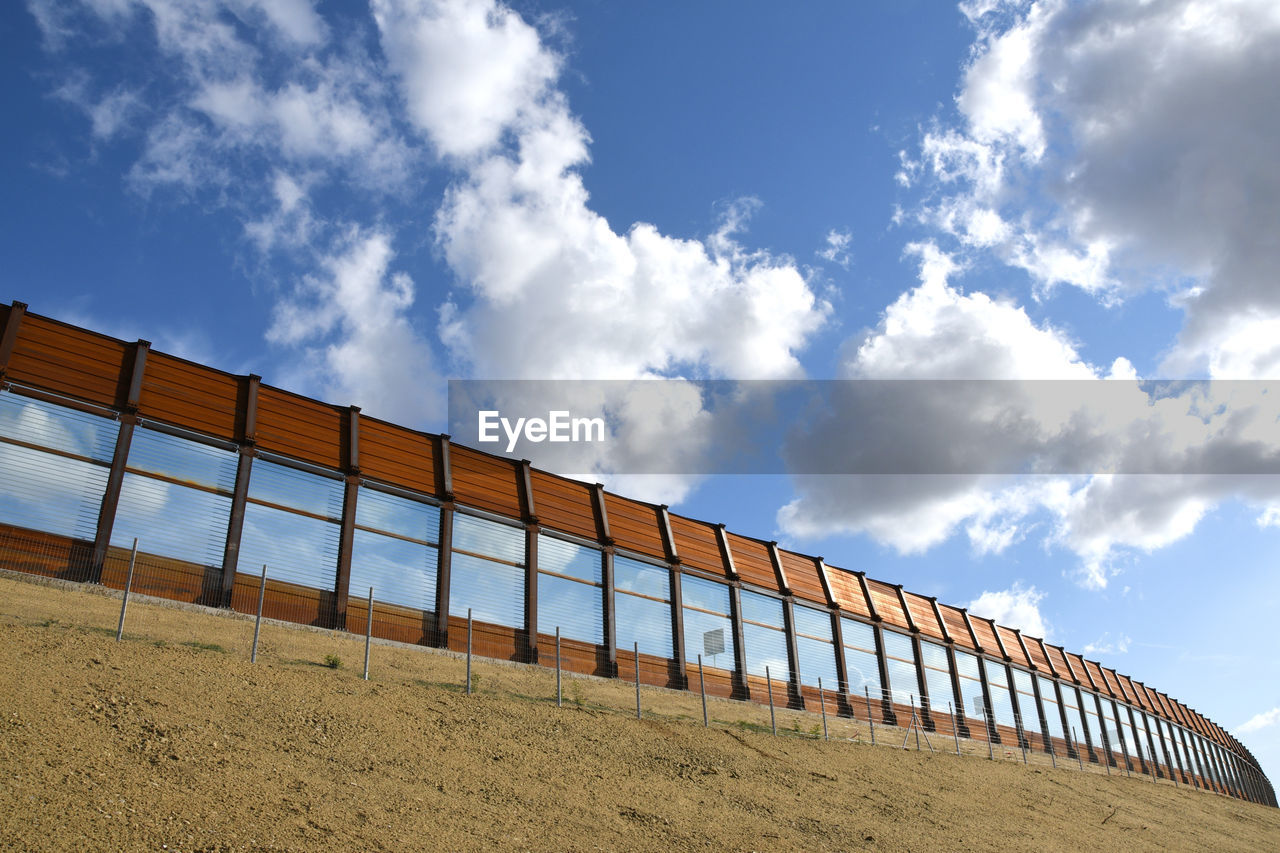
[236,502,340,589]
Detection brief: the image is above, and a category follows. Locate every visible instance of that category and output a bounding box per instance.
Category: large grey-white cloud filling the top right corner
[916,0,1280,378]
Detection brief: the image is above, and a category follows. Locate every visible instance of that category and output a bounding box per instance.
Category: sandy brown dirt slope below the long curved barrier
[0,573,1280,852]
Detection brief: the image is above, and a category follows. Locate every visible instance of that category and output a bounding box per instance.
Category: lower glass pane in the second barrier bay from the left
[111,474,231,566]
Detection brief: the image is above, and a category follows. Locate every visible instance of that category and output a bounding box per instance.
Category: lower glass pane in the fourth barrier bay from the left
[351,525,440,612]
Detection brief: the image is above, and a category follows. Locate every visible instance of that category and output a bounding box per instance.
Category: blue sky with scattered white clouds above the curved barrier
[0,0,1280,777]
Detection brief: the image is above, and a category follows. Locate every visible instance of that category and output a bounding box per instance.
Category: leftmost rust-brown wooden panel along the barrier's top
[6,314,133,409]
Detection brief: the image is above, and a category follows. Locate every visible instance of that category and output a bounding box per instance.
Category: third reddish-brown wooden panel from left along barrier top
[255,386,346,470]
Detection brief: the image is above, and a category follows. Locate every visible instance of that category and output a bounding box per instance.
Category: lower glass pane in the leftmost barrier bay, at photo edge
[0,438,110,542]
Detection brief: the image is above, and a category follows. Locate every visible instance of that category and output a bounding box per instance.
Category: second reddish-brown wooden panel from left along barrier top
[138,350,244,441]
